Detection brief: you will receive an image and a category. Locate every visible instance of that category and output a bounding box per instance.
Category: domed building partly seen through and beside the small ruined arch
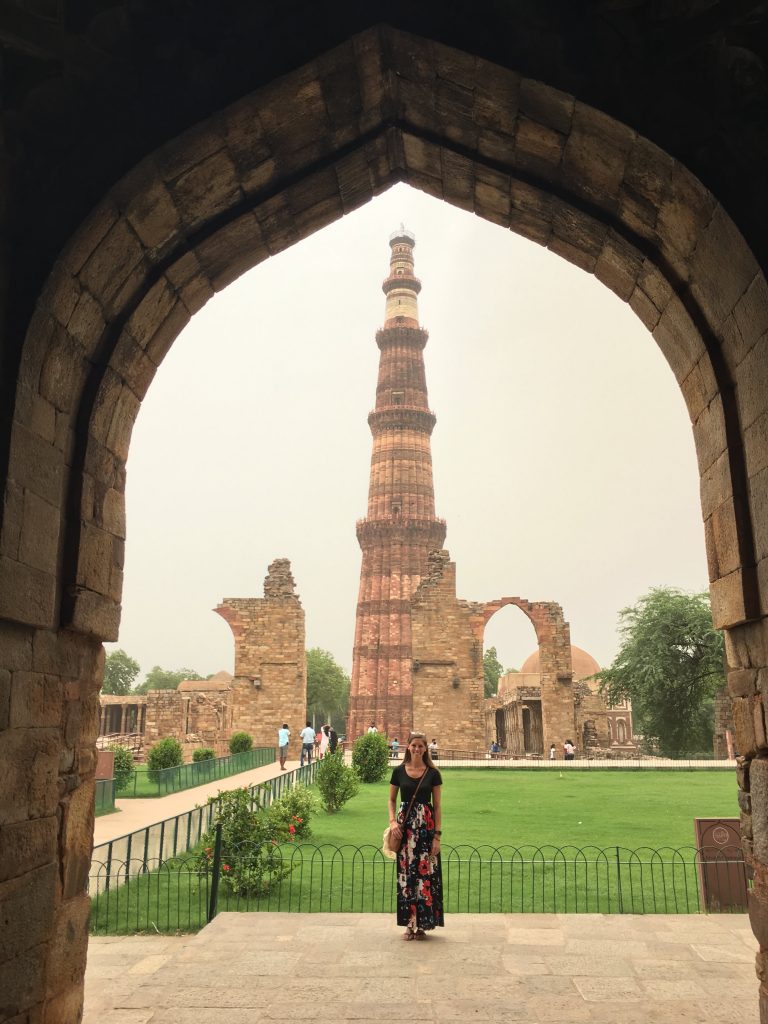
[485,644,638,758]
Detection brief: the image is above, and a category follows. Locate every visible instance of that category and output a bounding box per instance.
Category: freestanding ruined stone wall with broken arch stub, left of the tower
[215,558,306,758]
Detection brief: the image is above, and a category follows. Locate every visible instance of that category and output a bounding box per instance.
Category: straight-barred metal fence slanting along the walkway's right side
[90,761,318,889]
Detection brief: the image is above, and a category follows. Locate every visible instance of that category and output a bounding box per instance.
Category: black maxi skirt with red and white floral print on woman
[397,804,443,932]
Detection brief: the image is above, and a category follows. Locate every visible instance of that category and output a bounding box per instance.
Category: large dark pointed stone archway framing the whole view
[0,24,768,1021]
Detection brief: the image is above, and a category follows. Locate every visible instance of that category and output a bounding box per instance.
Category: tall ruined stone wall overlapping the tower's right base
[411,551,485,751]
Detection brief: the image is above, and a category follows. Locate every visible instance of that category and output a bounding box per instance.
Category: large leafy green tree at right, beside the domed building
[595,587,725,755]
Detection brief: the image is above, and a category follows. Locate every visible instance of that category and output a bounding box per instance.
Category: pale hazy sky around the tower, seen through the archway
[109,185,707,675]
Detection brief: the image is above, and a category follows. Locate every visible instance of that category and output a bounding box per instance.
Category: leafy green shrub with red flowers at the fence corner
[198,788,294,898]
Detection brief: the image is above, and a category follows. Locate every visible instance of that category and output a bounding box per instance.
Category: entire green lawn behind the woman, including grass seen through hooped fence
[91,769,735,934]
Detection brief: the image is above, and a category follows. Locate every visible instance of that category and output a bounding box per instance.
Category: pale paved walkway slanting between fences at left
[93,761,299,847]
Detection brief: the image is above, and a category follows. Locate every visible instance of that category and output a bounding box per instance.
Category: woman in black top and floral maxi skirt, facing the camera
[389,732,443,941]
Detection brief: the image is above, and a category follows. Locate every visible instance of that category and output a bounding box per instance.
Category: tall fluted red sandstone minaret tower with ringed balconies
[347,225,445,742]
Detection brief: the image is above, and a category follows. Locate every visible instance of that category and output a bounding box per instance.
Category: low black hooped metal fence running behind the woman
[90,843,748,934]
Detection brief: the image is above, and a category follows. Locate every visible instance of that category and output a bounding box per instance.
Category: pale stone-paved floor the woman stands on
[84,913,758,1024]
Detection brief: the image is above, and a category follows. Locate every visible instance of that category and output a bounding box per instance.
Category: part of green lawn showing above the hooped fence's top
[303,768,738,849]
